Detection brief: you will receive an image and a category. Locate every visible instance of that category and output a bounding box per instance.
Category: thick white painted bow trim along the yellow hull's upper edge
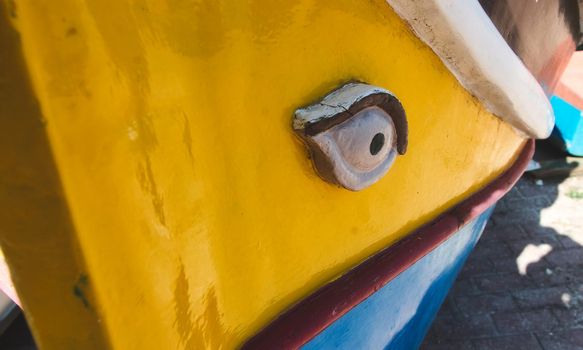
[387,0,555,138]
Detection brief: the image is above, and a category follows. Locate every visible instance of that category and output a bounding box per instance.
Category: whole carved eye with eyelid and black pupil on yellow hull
[293,83,408,191]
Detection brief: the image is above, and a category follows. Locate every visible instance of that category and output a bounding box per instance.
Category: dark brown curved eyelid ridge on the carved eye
[304,93,409,155]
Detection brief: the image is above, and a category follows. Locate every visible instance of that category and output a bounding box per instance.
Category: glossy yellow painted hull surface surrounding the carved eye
[0,0,524,349]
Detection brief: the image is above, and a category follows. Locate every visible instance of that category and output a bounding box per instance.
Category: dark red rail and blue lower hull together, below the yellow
[244,141,534,349]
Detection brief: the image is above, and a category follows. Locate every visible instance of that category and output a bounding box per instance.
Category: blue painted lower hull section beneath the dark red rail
[303,208,493,350]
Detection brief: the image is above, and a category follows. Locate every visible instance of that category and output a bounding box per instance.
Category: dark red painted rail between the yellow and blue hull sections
[243,140,534,349]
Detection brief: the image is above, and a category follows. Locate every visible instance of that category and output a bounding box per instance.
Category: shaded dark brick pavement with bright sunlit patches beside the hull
[421,177,583,350]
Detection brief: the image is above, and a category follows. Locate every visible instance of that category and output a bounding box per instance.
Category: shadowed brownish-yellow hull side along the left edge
[0,4,105,349]
